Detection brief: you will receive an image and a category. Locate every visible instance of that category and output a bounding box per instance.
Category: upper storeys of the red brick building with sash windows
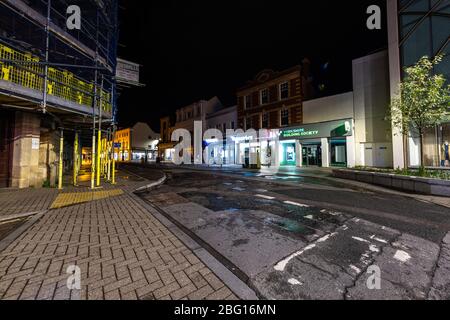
[237,61,310,130]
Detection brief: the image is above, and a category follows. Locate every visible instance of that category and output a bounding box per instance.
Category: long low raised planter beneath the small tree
[333,169,450,197]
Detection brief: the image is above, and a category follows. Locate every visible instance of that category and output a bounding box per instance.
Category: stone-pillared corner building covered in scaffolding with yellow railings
[0,0,118,188]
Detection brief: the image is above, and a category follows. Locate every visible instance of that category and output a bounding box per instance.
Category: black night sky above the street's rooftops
[118,0,387,130]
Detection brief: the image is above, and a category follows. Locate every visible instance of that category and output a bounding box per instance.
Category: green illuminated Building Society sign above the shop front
[280,119,352,139]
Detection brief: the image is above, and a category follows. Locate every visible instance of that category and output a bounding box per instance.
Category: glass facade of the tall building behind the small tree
[398,0,450,167]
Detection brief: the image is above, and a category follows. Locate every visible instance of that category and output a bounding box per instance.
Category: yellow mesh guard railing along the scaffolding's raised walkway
[0,43,112,112]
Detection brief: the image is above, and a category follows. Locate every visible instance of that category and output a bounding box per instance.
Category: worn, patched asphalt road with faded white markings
[121,166,450,299]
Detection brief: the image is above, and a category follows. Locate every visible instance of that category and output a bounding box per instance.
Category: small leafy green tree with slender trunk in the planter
[389,55,450,168]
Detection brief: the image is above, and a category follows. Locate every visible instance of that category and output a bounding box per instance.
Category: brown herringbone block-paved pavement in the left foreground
[0,170,236,300]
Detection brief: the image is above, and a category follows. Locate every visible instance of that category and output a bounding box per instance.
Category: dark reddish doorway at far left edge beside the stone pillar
[0,111,14,188]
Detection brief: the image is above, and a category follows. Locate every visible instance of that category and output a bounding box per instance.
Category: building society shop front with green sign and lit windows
[279,119,354,167]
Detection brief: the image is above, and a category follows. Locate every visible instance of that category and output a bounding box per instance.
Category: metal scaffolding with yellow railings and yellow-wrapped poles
[0,0,118,188]
